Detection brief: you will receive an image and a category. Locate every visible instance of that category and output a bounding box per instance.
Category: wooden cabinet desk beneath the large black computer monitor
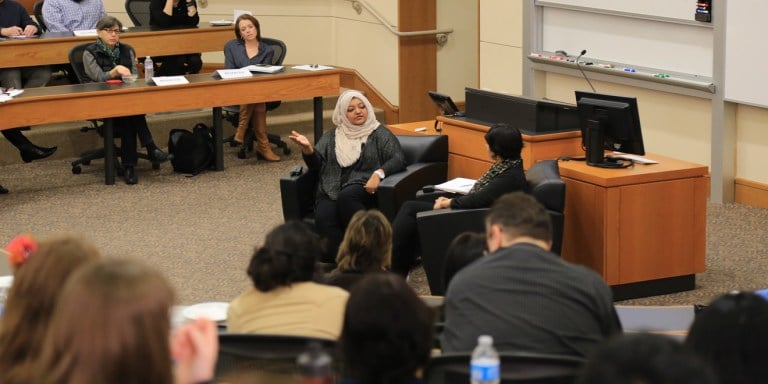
[560,155,709,300]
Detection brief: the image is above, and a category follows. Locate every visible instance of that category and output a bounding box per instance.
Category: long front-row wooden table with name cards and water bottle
[0,68,347,184]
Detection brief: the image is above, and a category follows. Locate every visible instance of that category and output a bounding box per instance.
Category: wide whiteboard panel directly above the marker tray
[541,6,714,77]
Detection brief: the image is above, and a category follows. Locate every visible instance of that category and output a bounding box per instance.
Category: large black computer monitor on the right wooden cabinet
[576,91,645,168]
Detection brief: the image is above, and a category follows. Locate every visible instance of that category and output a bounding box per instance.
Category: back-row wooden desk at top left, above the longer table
[0,26,235,68]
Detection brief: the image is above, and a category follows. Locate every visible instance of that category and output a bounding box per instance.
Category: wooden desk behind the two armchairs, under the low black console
[390,116,584,179]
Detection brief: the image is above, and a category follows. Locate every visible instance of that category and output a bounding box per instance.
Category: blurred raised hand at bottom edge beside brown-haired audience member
[171,319,219,384]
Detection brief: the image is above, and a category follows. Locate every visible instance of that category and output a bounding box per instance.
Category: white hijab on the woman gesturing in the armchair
[331,89,379,167]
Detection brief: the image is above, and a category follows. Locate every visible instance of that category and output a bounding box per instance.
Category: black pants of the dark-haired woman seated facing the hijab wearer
[392,200,435,277]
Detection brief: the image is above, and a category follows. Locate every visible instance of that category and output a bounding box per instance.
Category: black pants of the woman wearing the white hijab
[315,184,376,263]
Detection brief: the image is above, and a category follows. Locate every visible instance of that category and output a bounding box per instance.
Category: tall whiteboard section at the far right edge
[723,0,768,107]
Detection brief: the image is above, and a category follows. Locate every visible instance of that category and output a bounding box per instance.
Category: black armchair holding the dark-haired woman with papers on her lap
[416,160,565,295]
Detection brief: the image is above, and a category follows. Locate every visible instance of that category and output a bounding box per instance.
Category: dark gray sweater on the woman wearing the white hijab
[304,124,406,200]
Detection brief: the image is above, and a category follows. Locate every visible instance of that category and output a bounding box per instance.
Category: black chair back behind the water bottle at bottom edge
[424,352,585,384]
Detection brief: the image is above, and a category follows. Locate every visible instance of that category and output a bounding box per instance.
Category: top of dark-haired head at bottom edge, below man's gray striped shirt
[578,333,716,384]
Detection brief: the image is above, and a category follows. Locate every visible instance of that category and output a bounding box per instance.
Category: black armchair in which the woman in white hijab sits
[280,135,448,224]
